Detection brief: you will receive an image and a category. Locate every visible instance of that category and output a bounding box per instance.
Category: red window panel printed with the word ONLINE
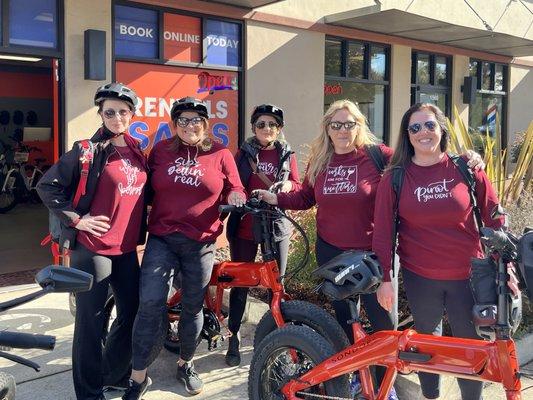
[163,14,202,63]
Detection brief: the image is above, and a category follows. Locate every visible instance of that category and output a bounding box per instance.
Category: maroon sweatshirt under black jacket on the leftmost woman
[77,146,146,255]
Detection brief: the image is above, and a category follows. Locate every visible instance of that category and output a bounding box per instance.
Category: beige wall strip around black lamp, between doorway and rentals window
[64,0,111,150]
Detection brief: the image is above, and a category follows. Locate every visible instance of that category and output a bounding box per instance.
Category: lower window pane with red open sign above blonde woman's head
[324,80,385,138]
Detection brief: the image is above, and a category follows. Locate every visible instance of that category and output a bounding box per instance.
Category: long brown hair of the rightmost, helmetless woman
[389,103,450,168]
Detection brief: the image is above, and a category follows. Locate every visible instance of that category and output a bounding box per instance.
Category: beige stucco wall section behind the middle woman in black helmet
[244,21,325,160]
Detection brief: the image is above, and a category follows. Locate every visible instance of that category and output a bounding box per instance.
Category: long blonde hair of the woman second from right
[306,99,379,186]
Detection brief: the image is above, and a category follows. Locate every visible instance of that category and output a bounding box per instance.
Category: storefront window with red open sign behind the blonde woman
[324,38,389,140]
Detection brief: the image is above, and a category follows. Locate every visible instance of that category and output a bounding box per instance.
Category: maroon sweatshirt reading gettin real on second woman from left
[148,139,245,242]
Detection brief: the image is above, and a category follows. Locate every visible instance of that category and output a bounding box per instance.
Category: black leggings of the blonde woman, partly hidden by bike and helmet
[316,237,394,385]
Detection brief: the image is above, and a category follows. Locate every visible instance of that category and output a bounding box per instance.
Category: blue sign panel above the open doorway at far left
[9,0,57,48]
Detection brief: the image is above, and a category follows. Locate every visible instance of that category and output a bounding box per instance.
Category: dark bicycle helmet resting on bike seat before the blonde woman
[315,250,383,300]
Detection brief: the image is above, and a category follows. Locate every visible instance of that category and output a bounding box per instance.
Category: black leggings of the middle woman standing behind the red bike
[228,236,289,335]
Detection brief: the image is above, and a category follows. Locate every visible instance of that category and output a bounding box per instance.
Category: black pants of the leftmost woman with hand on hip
[70,243,140,400]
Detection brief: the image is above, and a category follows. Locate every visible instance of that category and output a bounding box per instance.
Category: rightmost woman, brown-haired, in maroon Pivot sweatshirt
[372,103,503,400]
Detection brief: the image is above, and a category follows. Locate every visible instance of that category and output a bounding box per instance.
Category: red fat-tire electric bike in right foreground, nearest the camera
[248,228,533,400]
